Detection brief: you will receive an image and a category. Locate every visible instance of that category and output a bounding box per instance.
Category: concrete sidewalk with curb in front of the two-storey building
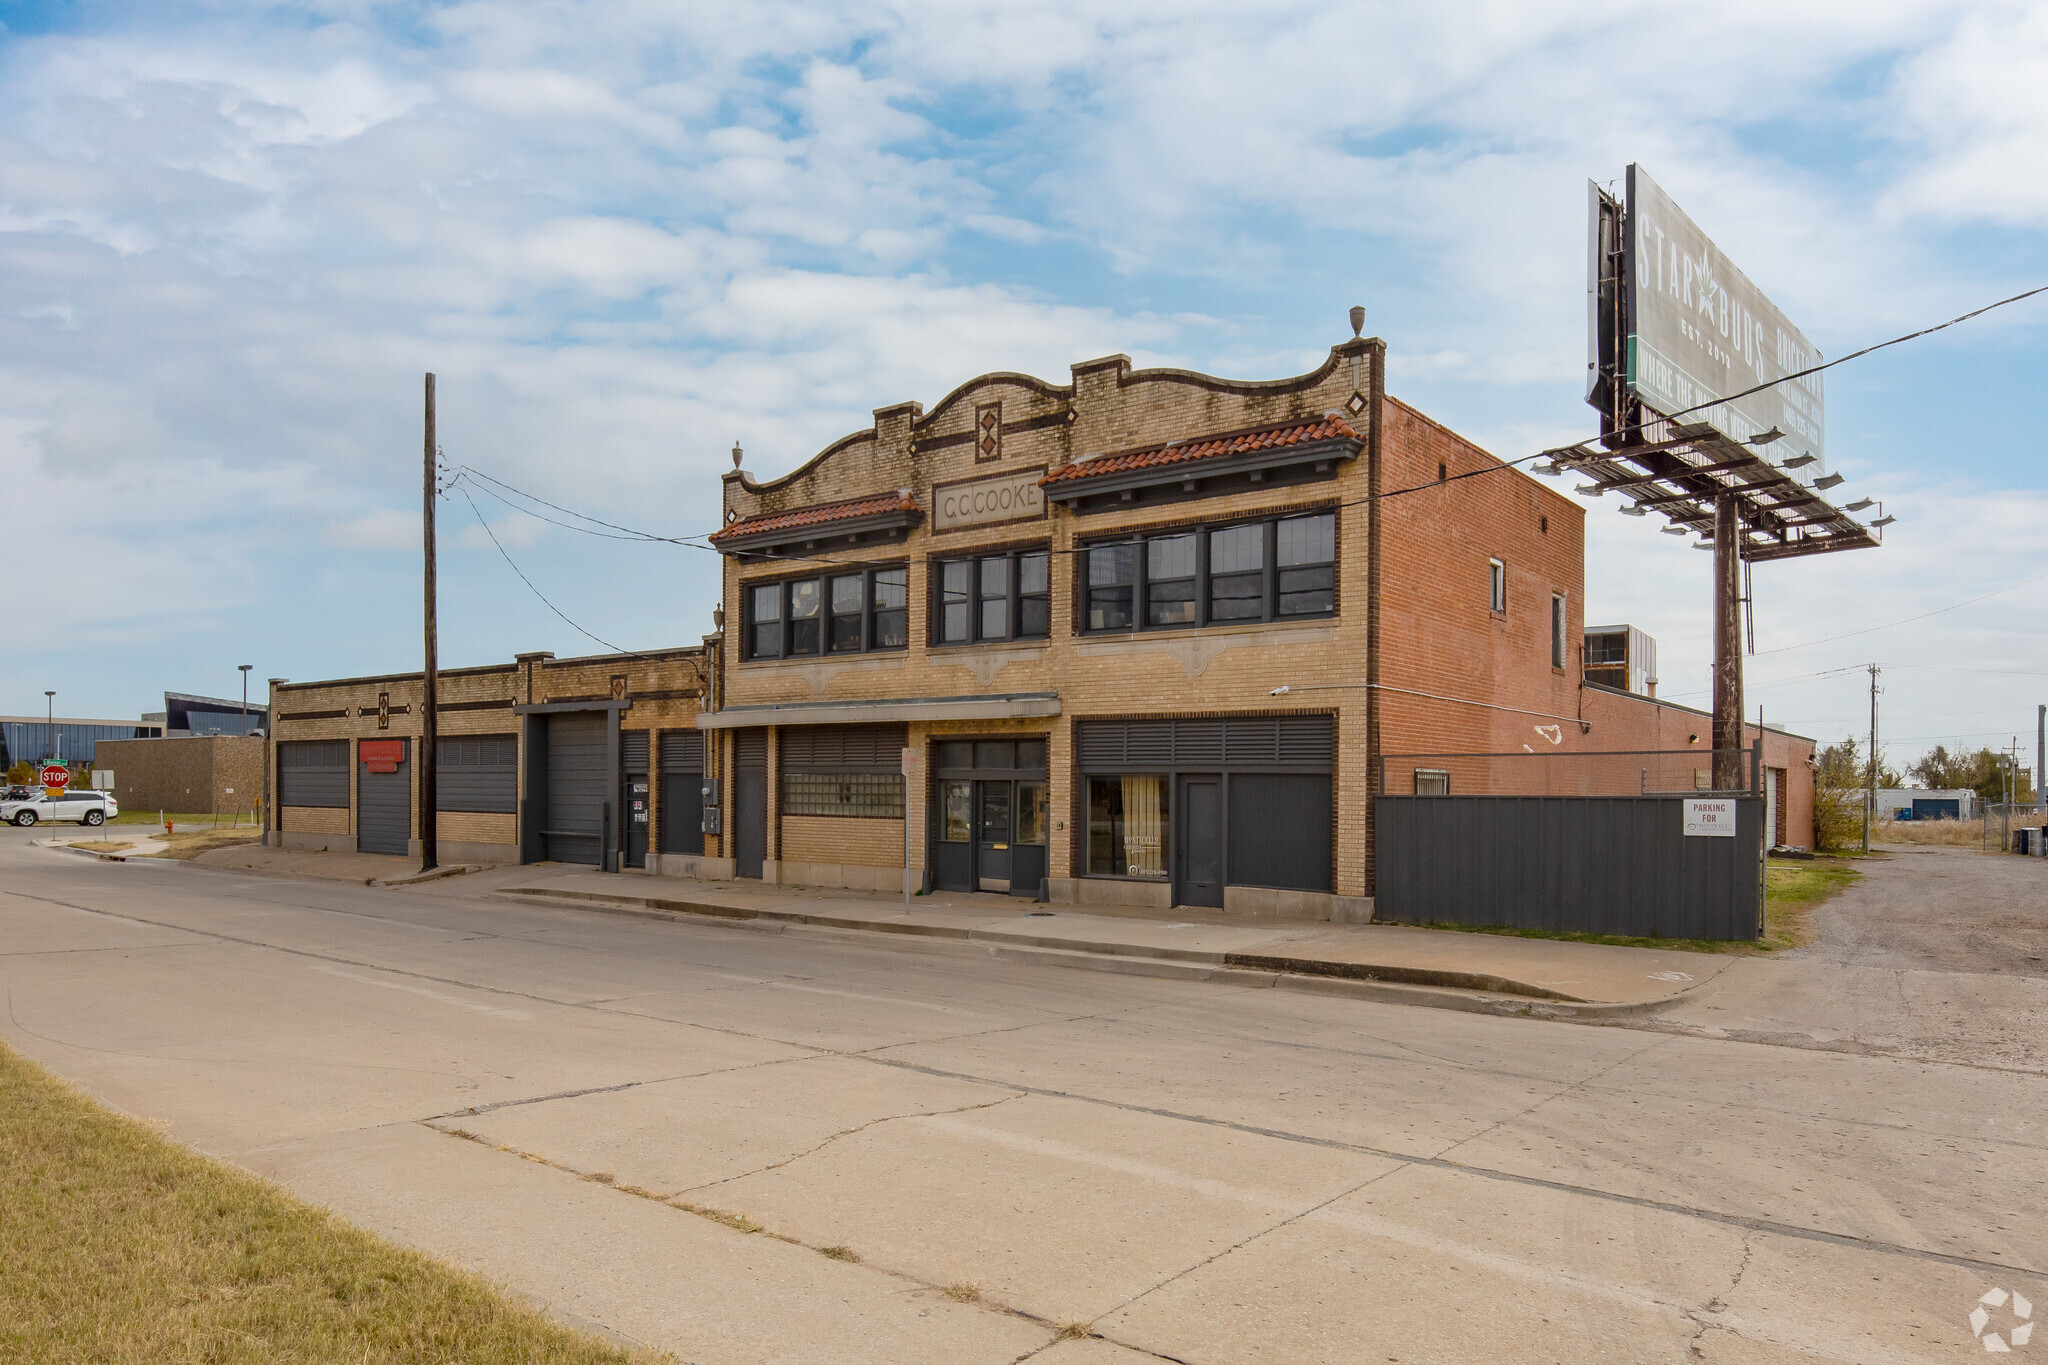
[496,868,1733,1015]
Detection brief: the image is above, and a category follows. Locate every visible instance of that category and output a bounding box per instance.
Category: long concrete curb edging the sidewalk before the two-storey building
[492,886,1706,1021]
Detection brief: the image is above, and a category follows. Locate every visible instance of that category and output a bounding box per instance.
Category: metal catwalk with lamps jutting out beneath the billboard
[1544,420,1878,563]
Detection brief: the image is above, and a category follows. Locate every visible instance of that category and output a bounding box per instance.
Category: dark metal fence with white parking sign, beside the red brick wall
[1374,749,1765,939]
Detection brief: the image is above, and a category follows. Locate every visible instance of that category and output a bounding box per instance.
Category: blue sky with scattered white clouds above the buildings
[0,0,2048,763]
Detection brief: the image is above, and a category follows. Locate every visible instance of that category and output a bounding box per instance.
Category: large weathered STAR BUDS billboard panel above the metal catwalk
[1587,166,1827,470]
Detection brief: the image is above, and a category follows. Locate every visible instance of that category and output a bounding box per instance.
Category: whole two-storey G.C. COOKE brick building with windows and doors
[708,327,1812,919]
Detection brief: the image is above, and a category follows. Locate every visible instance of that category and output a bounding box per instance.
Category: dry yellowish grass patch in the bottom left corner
[0,1044,670,1365]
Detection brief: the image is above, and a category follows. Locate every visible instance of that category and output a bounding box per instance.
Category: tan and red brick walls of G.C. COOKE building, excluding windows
[707,340,1810,917]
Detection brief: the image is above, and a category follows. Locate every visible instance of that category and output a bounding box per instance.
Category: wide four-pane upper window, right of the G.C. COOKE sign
[1081,512,1337,630]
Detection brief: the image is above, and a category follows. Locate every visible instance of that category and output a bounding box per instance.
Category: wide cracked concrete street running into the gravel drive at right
[0,831,2048,1365]
